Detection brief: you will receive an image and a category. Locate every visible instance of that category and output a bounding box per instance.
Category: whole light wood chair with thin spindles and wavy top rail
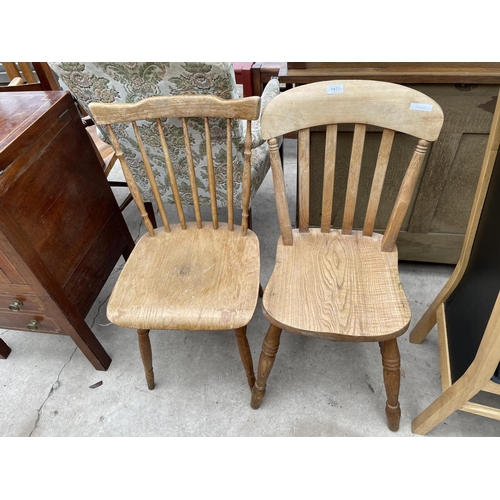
[90,95,260,389]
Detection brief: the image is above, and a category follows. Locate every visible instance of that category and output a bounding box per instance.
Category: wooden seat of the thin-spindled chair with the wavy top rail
[107,223,260,330]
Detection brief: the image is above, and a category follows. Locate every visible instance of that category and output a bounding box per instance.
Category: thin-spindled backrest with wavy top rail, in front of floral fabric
[89,95,260,236]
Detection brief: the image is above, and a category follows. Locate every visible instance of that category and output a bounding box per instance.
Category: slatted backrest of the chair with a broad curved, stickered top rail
[261,80,443,252]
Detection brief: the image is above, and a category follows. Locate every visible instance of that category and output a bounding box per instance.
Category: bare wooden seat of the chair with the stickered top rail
[263,228,411,342]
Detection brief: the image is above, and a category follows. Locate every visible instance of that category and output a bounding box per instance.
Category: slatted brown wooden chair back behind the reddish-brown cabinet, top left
[2,62,61,92]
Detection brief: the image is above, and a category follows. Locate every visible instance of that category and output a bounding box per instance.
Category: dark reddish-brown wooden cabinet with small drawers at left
[0,91,134,370]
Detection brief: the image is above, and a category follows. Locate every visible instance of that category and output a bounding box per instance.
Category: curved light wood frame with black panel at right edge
[410,95,500,434]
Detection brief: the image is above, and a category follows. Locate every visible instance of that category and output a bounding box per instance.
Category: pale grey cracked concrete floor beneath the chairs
[0,140,500,439]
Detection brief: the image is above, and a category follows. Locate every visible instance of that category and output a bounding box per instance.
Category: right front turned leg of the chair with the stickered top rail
[380,339,401,432]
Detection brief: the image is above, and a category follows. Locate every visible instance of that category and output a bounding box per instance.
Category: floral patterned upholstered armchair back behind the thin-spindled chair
[49,62,279,206]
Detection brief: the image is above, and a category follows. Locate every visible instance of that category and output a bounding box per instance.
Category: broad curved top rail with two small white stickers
[261,80,443,141]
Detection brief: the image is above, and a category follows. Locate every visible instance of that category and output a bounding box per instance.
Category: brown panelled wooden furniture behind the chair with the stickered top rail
[279,62,500,264]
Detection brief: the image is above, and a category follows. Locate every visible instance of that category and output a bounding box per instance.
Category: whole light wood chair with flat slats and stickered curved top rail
[251,80,443,431]
